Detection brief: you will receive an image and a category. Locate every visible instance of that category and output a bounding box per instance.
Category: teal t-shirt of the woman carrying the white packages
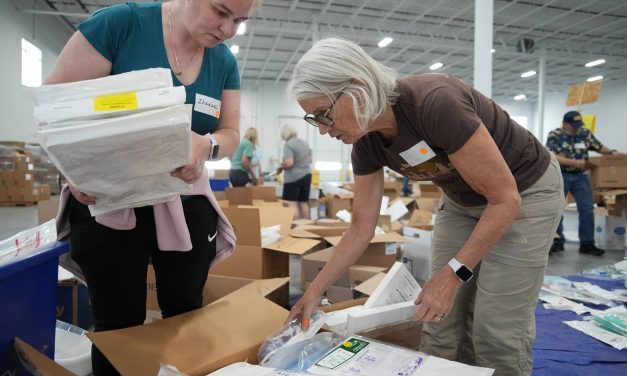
[78,2,240,135]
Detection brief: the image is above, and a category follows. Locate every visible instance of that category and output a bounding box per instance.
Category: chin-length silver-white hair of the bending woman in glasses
[287,38,398,130]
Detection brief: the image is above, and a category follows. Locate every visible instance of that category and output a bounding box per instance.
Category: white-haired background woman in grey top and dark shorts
[277,124,311,219]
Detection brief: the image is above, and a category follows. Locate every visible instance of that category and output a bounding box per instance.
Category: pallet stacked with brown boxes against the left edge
[0,141,51,206]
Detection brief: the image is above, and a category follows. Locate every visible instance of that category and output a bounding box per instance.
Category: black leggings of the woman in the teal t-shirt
[69,196,218,376]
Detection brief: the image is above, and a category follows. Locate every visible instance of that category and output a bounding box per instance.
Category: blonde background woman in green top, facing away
[229,128,263,187]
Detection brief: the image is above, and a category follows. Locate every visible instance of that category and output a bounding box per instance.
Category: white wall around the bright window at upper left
[0,1,72,141]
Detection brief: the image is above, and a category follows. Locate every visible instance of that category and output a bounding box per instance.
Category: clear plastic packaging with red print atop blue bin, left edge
[0,219,57,265]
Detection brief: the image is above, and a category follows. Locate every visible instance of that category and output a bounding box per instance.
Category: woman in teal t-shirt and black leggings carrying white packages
[44,0,255,376]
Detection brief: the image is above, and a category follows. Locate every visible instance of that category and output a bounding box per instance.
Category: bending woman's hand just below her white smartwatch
[412,266,463,322]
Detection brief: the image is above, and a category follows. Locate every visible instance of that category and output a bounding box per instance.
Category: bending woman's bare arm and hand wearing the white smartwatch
[414,124,521,321]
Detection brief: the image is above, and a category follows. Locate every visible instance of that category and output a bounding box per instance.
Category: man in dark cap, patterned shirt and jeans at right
[546,111,618,256]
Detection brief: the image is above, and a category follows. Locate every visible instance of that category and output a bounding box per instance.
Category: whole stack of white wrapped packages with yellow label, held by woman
[34,68,191,216]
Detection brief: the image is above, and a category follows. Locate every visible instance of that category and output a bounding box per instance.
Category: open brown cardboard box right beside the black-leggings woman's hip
[209,206,321,279]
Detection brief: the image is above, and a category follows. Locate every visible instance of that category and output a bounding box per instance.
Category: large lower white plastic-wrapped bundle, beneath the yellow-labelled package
[38,105,191,215]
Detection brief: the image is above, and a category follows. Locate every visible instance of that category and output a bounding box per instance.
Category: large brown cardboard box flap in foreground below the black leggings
[88,291,288,376]
